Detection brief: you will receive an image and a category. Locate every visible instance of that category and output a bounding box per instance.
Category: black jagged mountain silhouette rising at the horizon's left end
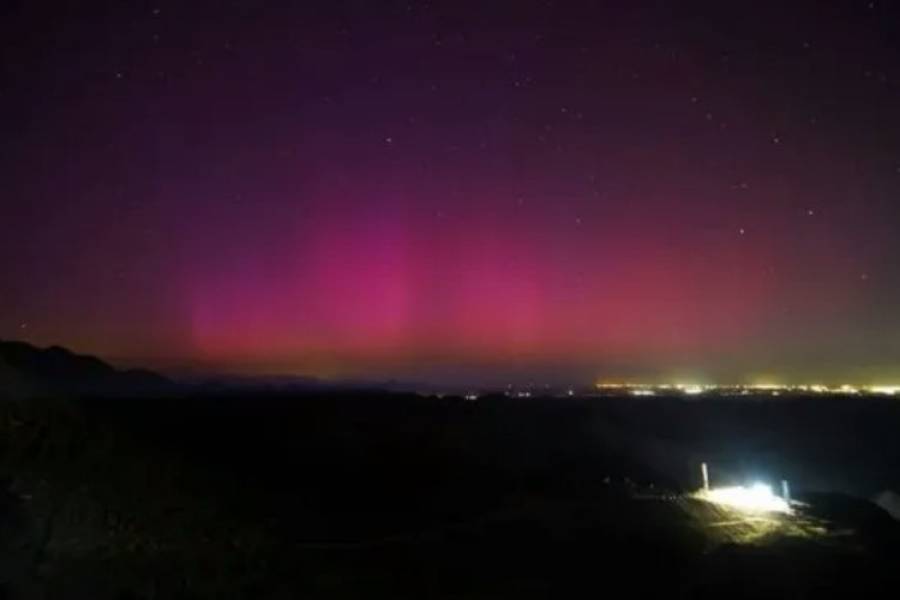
[0,340,175,396]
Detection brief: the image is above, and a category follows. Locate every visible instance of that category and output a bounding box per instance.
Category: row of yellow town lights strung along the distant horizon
[595,382,900,396]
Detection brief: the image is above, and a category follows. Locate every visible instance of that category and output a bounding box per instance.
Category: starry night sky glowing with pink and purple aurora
[0,0,900,383]
